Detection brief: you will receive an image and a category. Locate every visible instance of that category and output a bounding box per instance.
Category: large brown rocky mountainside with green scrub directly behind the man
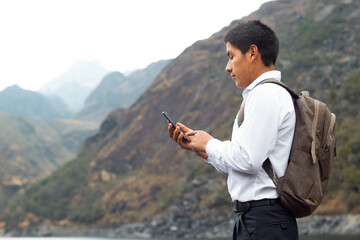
[1,0,360,238]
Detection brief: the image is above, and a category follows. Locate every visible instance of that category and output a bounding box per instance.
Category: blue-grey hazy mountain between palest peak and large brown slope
[75,60,171,122]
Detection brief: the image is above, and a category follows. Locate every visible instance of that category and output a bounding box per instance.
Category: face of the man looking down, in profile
[225,42,252,88]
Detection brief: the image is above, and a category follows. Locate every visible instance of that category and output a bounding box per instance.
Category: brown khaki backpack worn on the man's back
[238,79,336,218]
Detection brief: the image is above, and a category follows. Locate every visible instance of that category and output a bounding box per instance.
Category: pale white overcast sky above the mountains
[0,0,269,90]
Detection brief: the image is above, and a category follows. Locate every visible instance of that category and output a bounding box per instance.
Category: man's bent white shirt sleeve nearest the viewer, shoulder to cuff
[206,89,280,174]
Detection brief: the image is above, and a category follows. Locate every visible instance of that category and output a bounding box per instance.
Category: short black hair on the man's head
[224,20,279,67]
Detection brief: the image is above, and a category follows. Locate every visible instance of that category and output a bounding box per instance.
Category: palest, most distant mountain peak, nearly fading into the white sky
[39,61,108,112]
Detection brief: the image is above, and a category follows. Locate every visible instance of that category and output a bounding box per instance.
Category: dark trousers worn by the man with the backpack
[233,203,299,240]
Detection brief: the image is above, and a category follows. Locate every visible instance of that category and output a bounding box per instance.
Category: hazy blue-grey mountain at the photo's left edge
[0,85,71,120]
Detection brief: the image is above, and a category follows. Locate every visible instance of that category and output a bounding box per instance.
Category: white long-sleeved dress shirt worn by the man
[206,70,295,202]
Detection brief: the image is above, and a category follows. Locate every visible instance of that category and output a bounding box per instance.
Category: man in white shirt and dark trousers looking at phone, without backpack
[168,21,298,240]
